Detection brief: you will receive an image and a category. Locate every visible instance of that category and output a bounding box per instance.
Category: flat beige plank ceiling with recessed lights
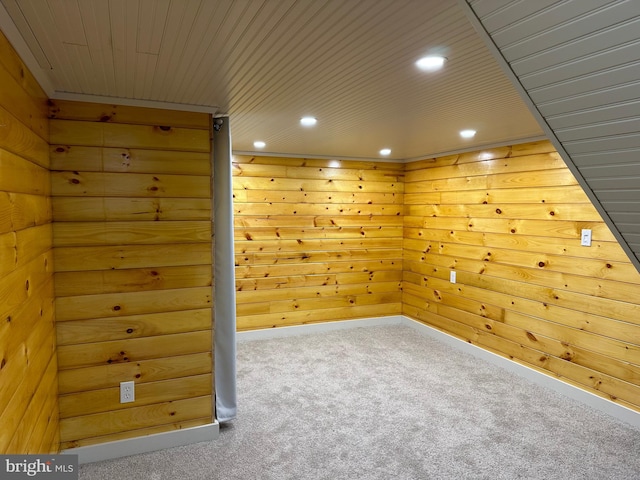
[0,0,543,160]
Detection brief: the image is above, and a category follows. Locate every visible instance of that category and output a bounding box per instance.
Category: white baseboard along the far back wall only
[236,315,405,342]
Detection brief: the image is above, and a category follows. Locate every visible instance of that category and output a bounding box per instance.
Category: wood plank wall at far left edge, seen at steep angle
[0,33,59,454]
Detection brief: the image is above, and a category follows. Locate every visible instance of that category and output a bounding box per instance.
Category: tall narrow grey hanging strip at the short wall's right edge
[212,117,237,422]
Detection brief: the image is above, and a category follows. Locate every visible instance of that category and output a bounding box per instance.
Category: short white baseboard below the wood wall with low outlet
[60,421,220,464]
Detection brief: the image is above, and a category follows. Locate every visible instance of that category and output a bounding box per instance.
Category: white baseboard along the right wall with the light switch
[402,316,640,428]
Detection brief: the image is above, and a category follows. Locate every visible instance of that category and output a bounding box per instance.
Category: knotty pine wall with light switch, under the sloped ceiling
[403,142,640,411]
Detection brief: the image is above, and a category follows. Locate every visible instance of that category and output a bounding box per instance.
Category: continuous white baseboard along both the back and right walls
[237,315,640,428]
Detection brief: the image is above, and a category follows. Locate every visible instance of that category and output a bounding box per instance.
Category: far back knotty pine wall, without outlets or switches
[233,155,404,330]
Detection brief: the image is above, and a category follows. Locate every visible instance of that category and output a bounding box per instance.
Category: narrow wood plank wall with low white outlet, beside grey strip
[50,101,213,448]
